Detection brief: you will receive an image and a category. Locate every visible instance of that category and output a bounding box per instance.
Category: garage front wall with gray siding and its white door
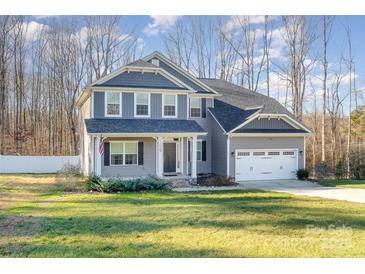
[229,137,305,181]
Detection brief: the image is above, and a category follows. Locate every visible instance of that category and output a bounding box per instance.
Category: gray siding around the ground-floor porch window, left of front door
[101,138,156,177]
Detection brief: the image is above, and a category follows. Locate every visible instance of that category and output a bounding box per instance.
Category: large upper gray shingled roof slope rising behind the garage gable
[199,78,294,118]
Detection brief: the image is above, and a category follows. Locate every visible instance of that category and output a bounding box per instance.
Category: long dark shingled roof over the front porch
[85,118,205,133]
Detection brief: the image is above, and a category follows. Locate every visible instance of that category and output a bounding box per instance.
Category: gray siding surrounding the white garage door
[229,137,305,177]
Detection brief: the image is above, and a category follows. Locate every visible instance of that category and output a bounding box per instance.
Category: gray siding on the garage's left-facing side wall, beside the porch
[207,112,227,176]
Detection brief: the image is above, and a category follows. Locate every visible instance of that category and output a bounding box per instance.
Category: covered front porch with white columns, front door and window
[87,119,206,178]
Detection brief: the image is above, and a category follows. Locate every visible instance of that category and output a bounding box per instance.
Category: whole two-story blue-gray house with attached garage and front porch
[78,52,310,181]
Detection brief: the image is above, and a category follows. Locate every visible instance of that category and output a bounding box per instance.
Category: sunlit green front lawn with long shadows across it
[0,175,365,257]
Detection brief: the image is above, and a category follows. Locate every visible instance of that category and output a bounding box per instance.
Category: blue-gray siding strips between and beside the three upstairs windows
[94,91,188,120]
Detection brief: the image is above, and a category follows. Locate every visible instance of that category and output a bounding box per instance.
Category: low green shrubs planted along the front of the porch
[87,176,168,193]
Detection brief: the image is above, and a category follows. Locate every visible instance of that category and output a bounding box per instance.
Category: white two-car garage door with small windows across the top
[235,149,298,181]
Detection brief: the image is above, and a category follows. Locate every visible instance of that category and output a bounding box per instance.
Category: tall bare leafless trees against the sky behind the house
[0,16,365,178]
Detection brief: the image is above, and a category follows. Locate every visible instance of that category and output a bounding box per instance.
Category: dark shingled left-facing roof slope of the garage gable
[209,97,259,132]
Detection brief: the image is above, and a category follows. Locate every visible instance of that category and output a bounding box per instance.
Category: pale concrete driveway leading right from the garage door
[239,180,365,203]
